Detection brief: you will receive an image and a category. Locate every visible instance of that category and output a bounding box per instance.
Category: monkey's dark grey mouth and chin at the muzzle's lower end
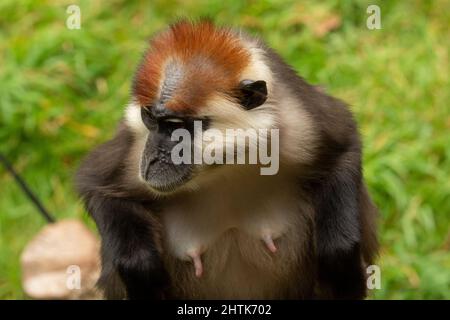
[141,161,193,193]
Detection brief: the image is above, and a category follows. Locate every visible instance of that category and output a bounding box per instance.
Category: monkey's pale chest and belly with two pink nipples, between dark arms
[162,196,302,299]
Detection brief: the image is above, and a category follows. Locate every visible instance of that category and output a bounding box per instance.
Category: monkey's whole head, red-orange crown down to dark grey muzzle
[126,23,275,193]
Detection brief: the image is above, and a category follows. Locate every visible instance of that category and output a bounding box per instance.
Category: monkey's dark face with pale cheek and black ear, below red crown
[135,80,267,193]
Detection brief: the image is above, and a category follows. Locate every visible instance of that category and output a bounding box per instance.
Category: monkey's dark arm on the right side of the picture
[314,151,366,299]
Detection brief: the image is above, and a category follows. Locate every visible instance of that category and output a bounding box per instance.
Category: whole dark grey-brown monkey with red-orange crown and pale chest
[77,21,377,299]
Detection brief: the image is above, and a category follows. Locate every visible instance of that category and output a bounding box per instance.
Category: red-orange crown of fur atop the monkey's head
[134,21,250,110]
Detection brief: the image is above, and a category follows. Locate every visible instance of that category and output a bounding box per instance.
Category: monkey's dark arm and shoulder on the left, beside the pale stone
[77,127,166,299]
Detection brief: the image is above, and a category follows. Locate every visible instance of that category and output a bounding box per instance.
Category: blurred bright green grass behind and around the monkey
[0,0,450,299]
